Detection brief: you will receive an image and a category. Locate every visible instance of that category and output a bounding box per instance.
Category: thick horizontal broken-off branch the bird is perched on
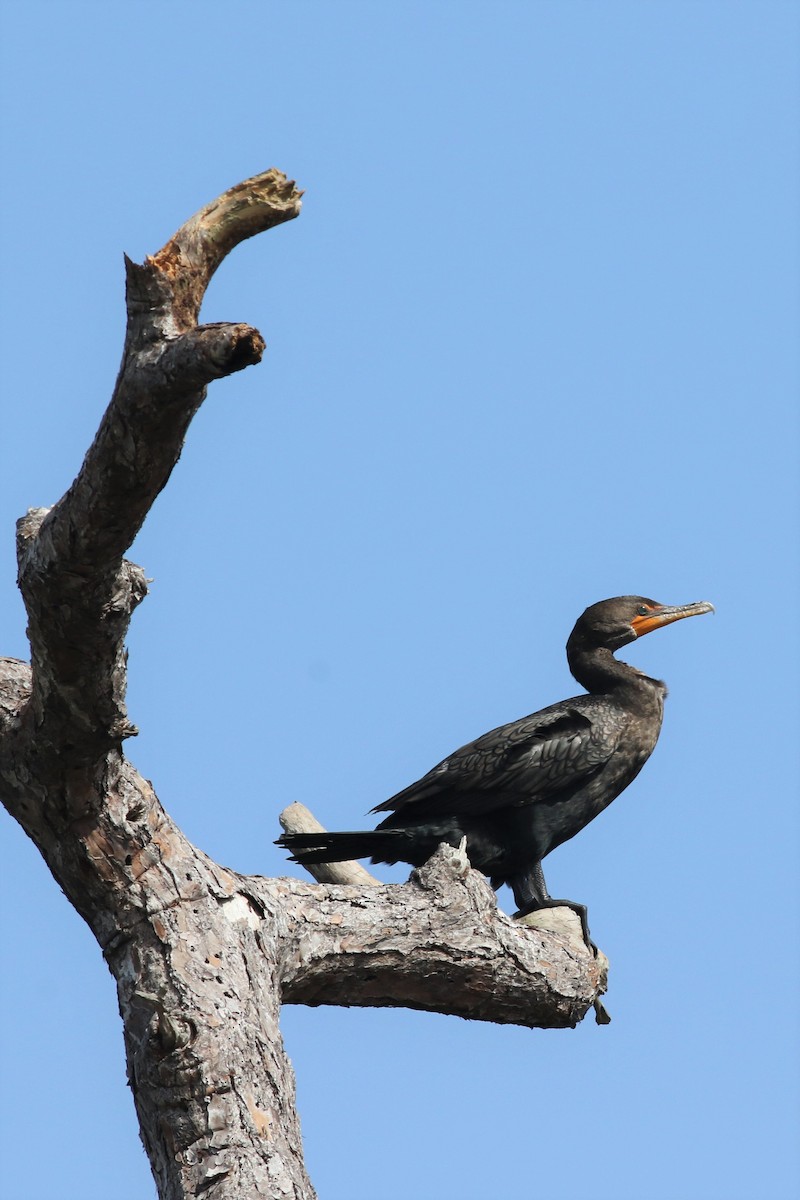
[269,846,606,1028]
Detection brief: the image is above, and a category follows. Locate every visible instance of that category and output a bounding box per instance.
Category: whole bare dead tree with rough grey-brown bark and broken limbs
[0,170,604,1200]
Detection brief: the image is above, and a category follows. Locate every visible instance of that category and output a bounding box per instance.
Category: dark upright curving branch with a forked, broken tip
[18,170,301,761]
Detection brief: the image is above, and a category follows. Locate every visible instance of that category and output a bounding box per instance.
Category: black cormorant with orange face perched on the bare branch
[277,596,714,944]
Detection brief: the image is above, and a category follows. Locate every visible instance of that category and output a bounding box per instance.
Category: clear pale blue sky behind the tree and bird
[0,7,800,1200]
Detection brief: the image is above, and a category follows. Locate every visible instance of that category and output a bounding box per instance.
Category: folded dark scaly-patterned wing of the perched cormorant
[372,704,621,818]
